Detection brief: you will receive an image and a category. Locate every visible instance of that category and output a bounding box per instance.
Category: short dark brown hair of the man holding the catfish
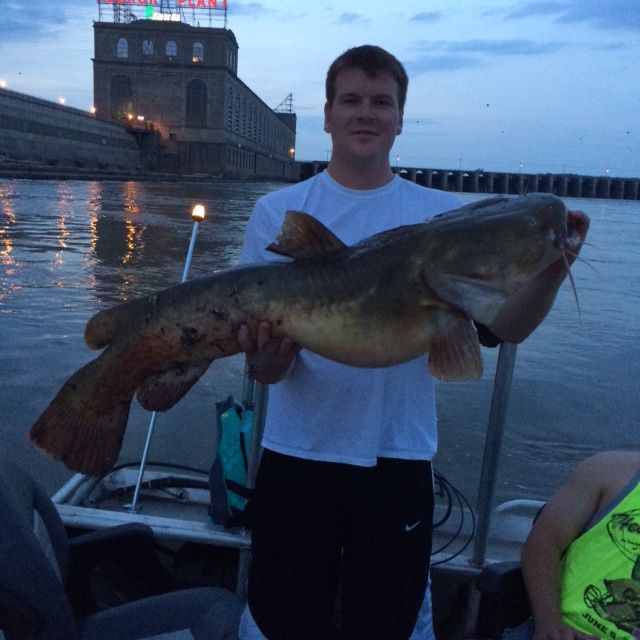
[325,44,409,111]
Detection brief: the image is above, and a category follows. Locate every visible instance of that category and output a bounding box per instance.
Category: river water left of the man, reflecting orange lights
[0,180,282,486]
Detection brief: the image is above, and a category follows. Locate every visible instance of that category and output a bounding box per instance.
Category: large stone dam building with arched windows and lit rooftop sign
[93,0,296,179]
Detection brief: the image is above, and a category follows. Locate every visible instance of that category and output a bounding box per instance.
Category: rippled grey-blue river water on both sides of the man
[0,180,640,501]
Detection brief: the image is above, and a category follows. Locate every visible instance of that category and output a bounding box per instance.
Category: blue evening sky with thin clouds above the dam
[0,0,640,177]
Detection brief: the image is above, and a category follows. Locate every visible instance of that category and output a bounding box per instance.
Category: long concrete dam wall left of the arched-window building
[0,88,143,177]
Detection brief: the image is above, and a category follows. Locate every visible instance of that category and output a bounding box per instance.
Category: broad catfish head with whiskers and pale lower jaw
[422,194,589,342]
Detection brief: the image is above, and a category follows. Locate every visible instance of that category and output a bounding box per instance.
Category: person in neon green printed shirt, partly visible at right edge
[505,451,640,640]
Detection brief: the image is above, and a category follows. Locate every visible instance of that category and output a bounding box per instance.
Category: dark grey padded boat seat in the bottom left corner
[0,457,242,640]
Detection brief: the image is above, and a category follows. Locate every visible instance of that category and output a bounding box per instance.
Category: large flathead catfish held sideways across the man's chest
[30,194,586,474]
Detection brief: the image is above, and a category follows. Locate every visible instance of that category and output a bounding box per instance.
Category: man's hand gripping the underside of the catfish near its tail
[238,322,300,384]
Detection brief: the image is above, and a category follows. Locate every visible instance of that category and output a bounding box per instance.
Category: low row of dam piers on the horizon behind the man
[300,161,640,200]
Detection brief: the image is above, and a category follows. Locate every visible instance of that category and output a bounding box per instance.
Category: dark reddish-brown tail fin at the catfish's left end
[29,387,133,476]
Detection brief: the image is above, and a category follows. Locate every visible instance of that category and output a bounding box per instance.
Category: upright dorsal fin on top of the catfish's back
[267,211,349,260]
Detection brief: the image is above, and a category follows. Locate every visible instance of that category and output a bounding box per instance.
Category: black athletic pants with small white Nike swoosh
[249,450,433,640]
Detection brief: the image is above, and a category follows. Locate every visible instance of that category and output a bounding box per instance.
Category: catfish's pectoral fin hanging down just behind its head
[429,313,482,381]
